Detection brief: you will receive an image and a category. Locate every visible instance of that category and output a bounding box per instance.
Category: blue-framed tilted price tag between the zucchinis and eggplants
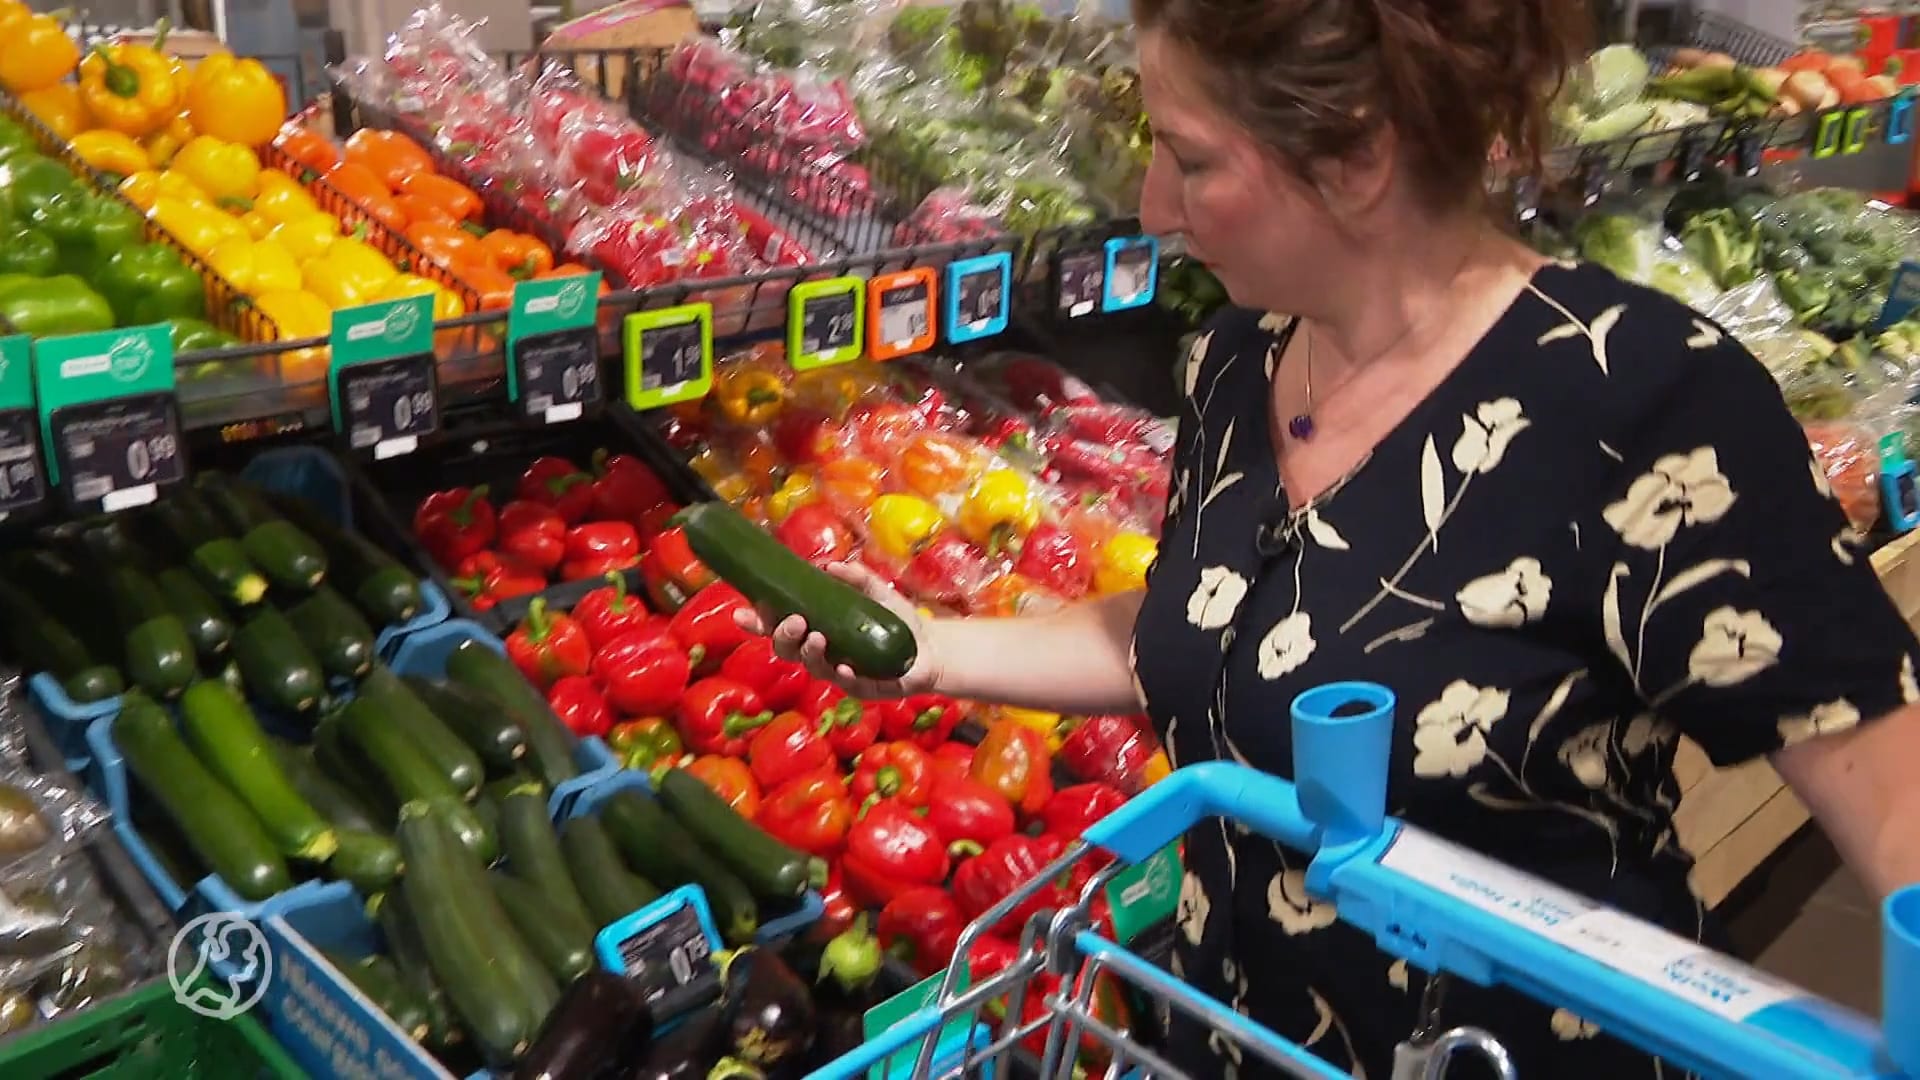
[593,886,720,1020]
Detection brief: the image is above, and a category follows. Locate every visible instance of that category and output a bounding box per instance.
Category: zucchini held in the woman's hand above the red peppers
[674,502,920,678]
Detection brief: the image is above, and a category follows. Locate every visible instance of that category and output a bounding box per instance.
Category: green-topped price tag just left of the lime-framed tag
[507,273,605,425]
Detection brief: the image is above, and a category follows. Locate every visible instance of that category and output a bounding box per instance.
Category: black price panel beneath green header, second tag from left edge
[48,394,186,513]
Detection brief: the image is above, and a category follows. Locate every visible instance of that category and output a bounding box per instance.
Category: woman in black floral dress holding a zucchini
[744,0,1920,1078]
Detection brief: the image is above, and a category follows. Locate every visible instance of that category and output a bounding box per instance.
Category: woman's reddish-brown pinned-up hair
[1133,0,1592,208]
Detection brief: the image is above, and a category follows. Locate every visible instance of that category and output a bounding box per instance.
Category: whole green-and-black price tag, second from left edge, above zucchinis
[33,327,186,513]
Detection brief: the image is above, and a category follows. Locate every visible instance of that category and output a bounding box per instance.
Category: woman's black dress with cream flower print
[1135,263,1920,1078]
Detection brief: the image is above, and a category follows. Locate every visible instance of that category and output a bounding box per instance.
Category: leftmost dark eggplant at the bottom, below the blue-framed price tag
[513,970,653,1080]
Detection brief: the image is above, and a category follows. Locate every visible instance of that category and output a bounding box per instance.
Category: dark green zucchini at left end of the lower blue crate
[111,690,294,899]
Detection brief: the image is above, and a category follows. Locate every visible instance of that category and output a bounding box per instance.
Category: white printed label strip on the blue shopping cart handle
[1380,828,1805,1024]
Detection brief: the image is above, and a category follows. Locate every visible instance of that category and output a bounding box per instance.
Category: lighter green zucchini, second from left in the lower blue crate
[180,678,338,863]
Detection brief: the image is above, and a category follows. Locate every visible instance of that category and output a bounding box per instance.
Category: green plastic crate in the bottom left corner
[0,978,307,1080]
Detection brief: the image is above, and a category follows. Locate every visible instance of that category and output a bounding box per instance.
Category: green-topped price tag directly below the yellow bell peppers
[326,296,440,461]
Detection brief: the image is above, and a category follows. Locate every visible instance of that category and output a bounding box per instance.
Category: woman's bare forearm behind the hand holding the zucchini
[924,592,1146,715]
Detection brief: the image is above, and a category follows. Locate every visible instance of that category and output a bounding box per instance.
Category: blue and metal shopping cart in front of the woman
[814,682,1920,1080]
